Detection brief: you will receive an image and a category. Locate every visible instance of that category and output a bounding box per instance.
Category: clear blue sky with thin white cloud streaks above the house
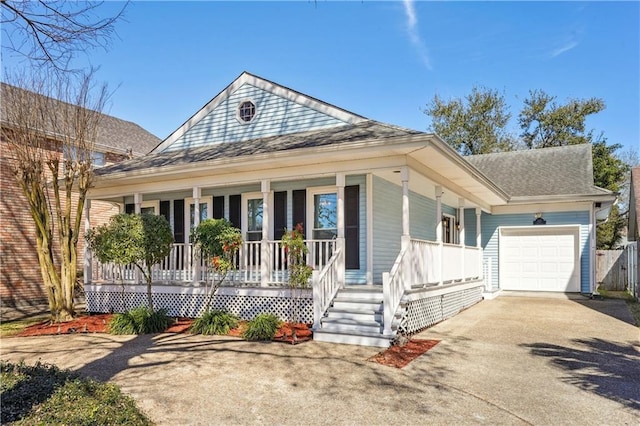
[3,1,640,154]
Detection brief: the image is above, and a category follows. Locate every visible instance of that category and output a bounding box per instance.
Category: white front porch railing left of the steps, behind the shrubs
[91,240,336,286]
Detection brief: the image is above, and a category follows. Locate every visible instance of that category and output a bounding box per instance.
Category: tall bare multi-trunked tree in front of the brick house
[1,73,107,321]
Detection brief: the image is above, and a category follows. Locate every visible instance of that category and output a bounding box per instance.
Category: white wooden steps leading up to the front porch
[313,287,395,347]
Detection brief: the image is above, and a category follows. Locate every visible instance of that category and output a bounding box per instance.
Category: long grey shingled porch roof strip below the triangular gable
[96,120,423,175]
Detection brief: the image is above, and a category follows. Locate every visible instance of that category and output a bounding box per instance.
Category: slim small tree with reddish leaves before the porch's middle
[191,219,242,312]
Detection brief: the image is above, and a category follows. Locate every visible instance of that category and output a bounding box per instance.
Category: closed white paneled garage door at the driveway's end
[500,225,580,292]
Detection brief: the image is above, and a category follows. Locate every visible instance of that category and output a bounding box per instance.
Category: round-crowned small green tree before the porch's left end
[87,213,173,310]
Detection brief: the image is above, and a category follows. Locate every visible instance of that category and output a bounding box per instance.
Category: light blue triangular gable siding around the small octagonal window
[164,84,346,151]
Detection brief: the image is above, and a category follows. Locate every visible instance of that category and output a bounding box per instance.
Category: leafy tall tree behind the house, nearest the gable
[424,87,514,155]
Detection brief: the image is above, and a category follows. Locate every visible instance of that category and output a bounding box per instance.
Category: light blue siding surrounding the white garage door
[481,211,591,293]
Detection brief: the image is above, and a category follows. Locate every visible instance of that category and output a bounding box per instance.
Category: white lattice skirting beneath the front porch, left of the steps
[85,285,313,323]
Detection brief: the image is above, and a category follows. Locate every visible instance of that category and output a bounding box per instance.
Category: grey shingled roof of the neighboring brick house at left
[0,83,160,156]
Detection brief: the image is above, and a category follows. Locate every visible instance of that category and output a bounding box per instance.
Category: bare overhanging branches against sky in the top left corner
[0,0,127,71]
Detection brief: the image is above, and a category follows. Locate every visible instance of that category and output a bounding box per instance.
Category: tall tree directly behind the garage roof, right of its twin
[518,90,605,149]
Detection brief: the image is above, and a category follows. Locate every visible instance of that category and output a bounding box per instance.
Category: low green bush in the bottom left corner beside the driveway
[0,361,152,425]
